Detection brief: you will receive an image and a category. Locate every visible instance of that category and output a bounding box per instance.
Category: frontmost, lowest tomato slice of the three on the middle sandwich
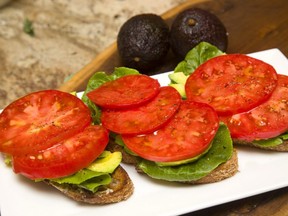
[122,100,219,162]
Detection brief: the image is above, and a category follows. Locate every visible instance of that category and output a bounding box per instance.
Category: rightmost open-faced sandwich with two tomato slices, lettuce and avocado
[169,43,288,151]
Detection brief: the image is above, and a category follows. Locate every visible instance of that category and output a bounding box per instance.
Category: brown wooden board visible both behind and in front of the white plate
[59,0,288,216]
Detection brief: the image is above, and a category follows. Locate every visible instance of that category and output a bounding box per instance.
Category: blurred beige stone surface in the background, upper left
[0,0,184,109]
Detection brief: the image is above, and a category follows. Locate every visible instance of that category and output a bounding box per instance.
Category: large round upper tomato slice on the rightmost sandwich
[185,54,277,115]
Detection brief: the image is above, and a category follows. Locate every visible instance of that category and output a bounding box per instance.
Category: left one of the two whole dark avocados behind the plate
[117,14,170,72]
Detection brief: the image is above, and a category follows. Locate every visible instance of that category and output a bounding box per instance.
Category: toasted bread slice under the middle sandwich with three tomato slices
[108,141,238,184]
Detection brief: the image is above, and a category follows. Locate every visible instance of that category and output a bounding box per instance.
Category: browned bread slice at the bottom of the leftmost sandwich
[45,166,134,205]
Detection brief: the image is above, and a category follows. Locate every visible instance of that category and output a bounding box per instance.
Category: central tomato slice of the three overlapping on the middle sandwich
[101,86,181,134]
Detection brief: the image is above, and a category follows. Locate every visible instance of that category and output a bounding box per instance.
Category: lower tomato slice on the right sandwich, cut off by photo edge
[220,75,288,141]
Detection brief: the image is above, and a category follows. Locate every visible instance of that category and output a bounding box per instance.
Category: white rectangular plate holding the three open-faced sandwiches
[0,49,288,216]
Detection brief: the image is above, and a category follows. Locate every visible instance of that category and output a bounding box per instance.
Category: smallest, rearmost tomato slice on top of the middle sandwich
[87,75,160,109]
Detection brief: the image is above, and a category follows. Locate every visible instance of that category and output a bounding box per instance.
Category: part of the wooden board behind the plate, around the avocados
[59,0,288,92]
